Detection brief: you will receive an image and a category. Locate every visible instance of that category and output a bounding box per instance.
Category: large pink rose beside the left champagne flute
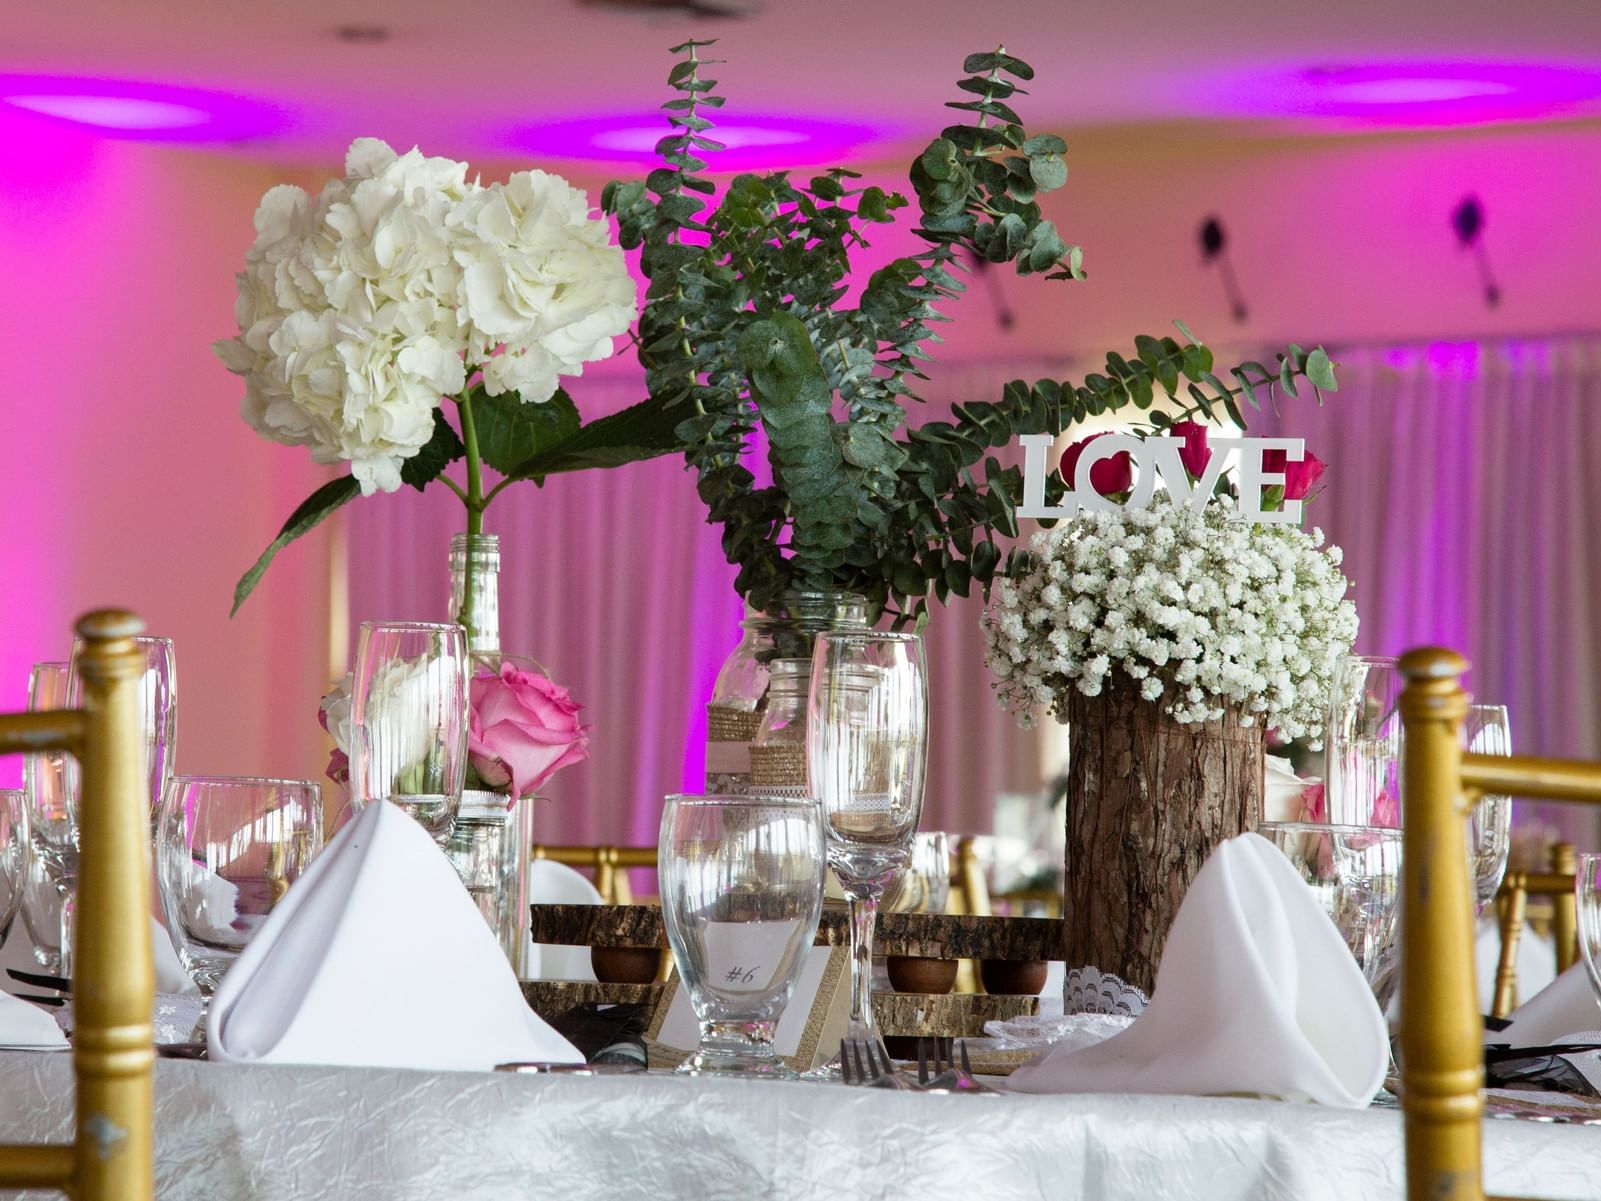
[467,663,589,799]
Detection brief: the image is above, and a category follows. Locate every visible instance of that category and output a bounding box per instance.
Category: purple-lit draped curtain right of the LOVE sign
[1252,336,1601,847]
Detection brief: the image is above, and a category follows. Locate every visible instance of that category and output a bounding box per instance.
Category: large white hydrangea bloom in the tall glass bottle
[215,138,636,495]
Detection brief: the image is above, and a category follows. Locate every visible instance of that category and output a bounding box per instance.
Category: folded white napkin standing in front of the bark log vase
[1010,834,1390,1108]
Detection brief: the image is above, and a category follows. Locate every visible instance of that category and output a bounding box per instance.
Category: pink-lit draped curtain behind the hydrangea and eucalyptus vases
[346,362,1061,846]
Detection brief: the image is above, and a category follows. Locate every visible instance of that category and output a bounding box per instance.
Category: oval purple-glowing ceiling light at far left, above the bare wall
[0,75,285,143]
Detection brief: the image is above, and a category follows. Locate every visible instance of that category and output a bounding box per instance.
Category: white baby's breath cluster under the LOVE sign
[983,492,1356,738]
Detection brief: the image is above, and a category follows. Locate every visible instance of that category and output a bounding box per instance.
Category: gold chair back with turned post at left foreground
[0,610,155,1201]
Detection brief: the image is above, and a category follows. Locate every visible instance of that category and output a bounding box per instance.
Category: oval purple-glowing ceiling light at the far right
[1202,62,1601,128]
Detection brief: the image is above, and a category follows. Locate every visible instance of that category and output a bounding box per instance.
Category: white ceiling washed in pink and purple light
[0,0,1601,162]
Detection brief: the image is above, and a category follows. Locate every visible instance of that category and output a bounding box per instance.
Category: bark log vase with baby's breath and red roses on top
[983,423,1356,1007]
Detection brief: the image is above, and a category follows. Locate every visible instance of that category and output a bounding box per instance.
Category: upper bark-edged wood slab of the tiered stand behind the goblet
[532,905,1065,961]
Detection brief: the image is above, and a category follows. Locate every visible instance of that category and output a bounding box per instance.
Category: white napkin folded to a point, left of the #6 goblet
[207,804,583,1071]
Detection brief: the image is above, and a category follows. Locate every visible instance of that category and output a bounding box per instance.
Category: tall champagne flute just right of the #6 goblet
[807,631,929,1063]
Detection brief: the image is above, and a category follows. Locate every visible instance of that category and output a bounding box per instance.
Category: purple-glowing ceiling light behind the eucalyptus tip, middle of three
[504,114,889,171]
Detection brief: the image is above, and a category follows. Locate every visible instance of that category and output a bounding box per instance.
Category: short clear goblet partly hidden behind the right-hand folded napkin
[1257,821,1401,1002]
